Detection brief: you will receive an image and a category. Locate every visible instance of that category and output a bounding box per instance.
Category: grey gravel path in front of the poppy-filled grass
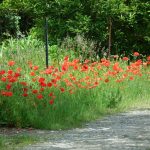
[24,110,150,150]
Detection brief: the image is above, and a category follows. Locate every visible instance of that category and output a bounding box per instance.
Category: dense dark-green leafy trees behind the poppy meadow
[0,0,150,54]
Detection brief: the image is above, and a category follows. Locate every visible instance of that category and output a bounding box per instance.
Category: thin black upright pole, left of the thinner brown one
[45,17,48,68]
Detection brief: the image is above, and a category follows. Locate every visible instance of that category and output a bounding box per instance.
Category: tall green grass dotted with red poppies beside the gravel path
[0,37,150,129]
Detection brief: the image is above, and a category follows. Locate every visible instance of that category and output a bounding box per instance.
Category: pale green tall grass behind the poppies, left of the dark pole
[0,36,45,66]
